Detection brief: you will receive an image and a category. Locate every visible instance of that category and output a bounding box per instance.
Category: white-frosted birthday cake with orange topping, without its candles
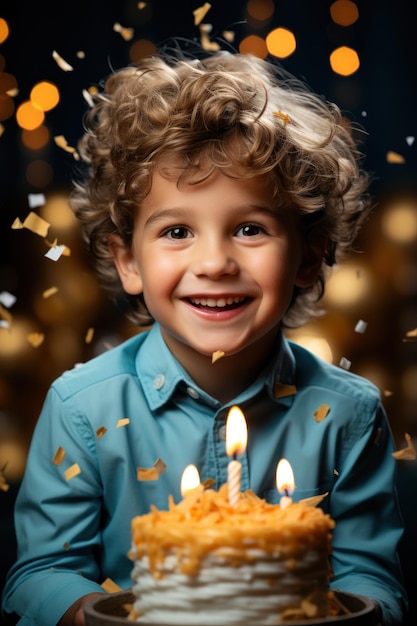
[129,485,335,626]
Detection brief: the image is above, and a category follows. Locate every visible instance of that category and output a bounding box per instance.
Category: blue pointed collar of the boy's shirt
[136,323,296,411]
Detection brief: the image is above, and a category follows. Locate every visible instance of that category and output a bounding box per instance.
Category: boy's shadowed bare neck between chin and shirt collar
[159,328,279,404]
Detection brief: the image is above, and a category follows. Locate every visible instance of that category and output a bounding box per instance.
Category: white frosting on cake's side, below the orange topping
[132,550,328,626]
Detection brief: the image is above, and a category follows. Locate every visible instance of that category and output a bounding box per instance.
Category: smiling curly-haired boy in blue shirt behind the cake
[3,53,405,626]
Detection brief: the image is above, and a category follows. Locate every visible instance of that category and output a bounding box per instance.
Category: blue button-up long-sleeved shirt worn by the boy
[3,324,404,626]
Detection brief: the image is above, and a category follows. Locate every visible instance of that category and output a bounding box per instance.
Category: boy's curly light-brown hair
[70,52,370,327]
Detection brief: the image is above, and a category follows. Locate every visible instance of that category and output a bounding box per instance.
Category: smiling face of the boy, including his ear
[110,171,316,361]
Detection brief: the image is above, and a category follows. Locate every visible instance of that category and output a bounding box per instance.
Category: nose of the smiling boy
[193,240,239,279]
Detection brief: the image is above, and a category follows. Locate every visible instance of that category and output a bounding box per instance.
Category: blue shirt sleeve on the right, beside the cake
[330,401,405,626]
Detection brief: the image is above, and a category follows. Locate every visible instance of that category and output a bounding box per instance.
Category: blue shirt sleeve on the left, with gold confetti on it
[3,388,107,626]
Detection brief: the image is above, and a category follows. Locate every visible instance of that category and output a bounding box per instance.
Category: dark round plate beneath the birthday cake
[84,591,380,626]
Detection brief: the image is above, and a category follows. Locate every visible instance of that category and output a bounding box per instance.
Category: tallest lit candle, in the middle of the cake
[226,406,248,506]
